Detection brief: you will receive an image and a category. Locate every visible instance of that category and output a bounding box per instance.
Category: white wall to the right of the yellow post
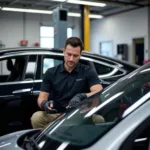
[91,8,148,63]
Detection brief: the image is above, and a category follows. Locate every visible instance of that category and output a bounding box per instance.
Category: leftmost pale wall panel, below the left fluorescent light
[0,12,23,47]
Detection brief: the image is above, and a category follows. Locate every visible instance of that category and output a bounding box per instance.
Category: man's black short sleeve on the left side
[41,69,52,93]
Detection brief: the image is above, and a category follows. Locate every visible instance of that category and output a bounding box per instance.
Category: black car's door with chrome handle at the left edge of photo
[0,53,36,135]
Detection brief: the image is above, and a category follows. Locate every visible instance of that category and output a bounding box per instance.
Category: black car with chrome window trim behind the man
[0,48,138,135]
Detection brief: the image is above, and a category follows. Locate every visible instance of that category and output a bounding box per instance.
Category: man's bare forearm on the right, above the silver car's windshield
[86,84,103,97]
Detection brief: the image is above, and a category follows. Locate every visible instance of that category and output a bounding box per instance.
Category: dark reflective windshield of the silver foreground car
[38,65,150,148]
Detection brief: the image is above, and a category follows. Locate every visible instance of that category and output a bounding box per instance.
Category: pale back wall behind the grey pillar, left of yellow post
[0,11,80,48]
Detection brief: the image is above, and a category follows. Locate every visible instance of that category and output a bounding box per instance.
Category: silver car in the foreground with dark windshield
[0,63,150,150]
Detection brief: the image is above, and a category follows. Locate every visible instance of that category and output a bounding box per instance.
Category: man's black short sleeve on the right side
[86,68,101,87]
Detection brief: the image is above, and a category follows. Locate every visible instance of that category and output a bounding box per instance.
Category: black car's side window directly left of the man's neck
[43,57,63,74]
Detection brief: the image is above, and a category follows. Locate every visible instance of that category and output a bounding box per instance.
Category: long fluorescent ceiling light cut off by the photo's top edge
[52,0,106,7]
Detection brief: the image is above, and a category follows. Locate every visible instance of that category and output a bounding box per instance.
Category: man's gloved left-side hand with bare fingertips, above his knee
[41,100,57,114]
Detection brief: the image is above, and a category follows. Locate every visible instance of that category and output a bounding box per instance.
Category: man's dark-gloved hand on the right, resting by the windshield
[67,93,87,108]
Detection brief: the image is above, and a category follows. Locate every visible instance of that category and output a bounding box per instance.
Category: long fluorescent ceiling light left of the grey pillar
[2,7,53,14]
